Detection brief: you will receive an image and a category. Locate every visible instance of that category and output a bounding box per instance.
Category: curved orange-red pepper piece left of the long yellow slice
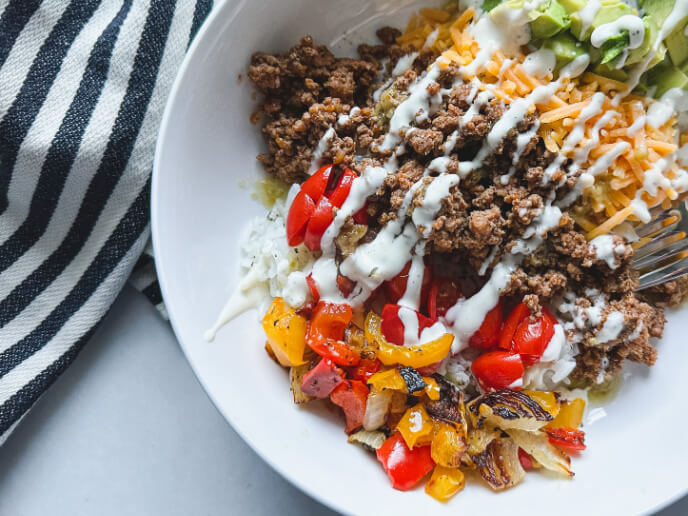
[306,301,361,366]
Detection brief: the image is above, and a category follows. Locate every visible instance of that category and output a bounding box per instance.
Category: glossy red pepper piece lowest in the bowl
[376,432,435,491]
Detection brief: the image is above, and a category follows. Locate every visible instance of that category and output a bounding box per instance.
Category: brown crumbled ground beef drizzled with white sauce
[248,32,688,388]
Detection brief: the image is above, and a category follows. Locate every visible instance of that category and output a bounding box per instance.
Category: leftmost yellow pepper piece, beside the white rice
[263,297,308,367]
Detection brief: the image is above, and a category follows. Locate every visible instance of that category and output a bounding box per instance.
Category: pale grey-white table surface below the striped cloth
[0,288,688,516]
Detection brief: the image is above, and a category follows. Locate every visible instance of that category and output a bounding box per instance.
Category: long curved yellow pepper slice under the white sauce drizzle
[365,312,454,368]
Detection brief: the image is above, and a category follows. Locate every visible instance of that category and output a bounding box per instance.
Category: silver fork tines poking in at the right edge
[633,201,688,290]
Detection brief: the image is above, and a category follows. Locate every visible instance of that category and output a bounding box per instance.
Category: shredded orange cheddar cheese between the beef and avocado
[398,7,688,239]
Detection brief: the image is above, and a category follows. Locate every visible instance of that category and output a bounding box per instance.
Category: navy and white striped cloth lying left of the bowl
[0,0,212,443]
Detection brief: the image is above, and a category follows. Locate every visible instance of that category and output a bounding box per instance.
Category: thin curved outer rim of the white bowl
[150,0,688,514]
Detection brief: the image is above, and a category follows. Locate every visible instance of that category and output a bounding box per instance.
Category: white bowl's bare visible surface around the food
[152,0,688,516]
